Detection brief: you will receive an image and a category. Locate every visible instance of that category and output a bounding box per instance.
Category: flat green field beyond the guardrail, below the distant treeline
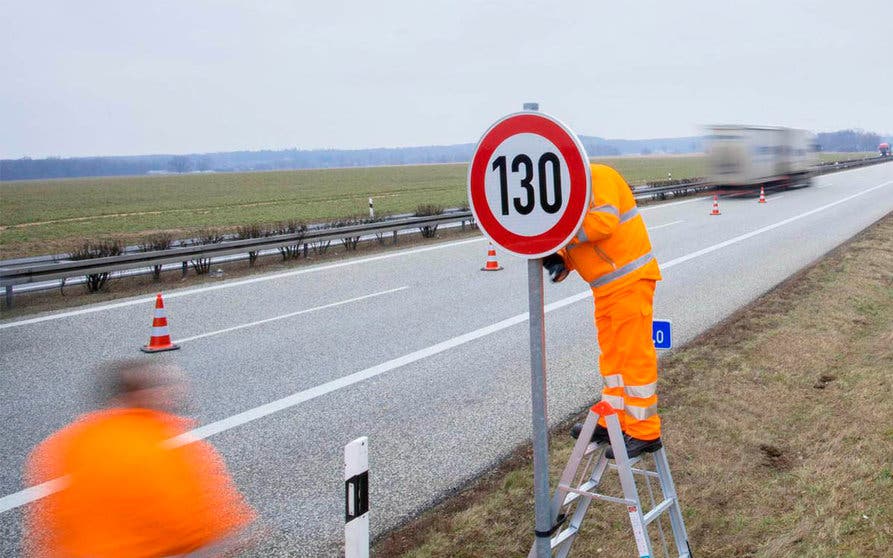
[0,155,703,258]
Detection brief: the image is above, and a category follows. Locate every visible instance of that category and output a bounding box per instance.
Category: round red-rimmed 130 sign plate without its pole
[468,112,590,258]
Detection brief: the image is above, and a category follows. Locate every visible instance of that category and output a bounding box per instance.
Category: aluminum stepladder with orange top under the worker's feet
[529,401,691,558]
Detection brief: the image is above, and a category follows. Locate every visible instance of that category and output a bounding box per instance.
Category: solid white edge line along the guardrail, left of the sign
[0,237,486,329]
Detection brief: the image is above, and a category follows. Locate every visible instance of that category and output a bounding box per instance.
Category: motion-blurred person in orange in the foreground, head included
[23,361,255,558]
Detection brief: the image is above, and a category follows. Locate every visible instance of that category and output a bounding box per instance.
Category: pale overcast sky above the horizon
[0,0,893,158]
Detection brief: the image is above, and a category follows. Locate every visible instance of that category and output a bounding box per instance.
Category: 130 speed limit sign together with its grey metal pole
[468,103,591,558]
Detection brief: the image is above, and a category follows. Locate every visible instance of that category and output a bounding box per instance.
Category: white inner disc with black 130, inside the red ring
[484,133,571,236]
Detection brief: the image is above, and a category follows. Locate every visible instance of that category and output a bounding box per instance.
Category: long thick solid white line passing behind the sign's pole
[0,180,893,513]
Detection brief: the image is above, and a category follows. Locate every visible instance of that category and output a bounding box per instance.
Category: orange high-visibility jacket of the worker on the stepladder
[558,164,661,296]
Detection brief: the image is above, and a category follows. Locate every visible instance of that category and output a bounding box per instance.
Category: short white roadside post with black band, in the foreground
[344,436,369,558]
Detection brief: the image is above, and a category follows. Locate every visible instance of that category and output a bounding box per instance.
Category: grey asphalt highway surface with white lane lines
[0,165,893,556]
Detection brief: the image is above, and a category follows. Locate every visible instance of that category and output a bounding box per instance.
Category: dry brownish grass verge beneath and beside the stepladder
[375,215,893,558]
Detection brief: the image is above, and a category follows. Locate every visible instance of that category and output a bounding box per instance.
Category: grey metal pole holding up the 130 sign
[524,103,552,558]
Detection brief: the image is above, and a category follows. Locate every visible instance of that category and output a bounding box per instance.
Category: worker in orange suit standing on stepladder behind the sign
[543,165,661,458]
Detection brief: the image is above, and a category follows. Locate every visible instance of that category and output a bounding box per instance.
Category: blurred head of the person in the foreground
[98,359,186,413]
